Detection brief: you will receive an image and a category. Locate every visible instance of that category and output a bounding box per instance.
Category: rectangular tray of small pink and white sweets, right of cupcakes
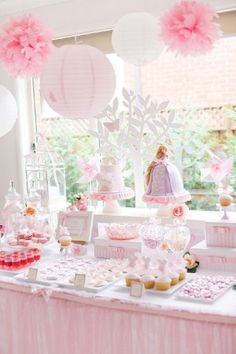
[177,275,236,303]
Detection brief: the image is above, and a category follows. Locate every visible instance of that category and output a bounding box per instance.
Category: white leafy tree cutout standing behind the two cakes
[89,88,182,206]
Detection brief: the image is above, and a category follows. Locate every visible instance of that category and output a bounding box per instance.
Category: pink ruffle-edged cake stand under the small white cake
[90,188,134,214]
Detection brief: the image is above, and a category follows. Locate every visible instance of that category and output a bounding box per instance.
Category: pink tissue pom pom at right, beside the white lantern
[160,1,222,56]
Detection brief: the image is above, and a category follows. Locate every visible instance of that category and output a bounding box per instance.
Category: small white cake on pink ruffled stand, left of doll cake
[97,157,124,193]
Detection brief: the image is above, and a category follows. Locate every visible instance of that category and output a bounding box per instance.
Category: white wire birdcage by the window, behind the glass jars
[25,145,66,207]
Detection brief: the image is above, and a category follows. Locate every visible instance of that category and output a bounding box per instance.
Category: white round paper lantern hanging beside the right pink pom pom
[112,12,164,65]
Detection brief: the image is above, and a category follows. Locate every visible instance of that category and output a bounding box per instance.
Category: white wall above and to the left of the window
[0,0,236,207]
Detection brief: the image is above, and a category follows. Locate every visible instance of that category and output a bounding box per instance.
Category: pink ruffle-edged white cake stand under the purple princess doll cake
[143,192,191,217]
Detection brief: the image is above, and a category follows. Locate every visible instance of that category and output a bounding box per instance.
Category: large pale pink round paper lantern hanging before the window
[41,45,115,119]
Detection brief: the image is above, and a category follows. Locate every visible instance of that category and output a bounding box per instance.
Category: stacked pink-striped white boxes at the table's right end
[190,220,236,272]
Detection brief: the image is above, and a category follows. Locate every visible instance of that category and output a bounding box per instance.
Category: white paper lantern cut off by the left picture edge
[0,86,17,137]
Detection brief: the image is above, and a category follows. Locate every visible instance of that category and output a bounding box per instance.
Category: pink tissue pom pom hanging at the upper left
[0,15,53,76]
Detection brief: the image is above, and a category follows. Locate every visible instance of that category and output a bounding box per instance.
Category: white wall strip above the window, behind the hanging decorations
[0,0,236,37]
